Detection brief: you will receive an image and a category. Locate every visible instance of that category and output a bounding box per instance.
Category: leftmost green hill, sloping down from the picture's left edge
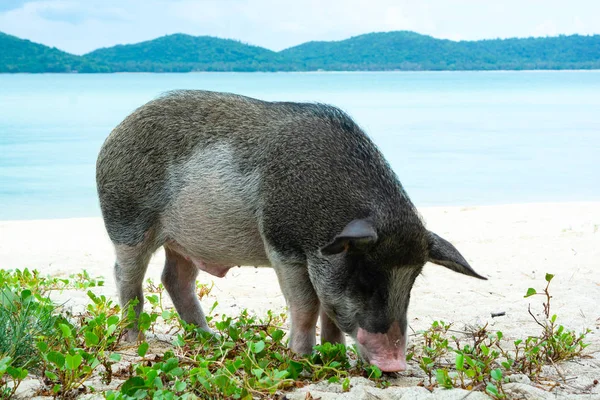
[0,32,109,72]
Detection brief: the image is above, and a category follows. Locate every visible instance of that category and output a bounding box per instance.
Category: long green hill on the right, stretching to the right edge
[281,31,600,70]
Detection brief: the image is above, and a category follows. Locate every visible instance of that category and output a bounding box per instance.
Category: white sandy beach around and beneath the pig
[0,203,600,399]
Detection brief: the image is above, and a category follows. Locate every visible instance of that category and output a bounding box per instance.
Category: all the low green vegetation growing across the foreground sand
[0,270,588,400]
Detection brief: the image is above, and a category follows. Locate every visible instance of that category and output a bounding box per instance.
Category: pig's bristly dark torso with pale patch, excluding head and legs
[97,91,418,255]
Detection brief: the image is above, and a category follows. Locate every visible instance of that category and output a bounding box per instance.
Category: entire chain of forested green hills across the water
[0,31,600,73]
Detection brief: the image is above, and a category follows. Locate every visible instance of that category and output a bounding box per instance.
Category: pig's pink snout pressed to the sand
[356,322,406,372]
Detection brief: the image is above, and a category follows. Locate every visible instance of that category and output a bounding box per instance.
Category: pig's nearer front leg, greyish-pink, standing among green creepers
[274,263,319,354]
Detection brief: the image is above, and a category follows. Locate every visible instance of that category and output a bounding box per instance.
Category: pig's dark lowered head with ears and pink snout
[309,219,486,372]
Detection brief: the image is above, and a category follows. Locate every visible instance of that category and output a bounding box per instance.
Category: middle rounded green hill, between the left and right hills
[84,34,282,72]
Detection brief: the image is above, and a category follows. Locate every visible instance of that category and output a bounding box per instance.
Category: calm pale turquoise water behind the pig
[0,71,600,220]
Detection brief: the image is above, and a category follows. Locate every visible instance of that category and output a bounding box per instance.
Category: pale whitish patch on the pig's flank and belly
[161,149,270,276]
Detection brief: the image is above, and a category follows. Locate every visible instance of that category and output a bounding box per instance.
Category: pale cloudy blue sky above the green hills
[0,0,600,54]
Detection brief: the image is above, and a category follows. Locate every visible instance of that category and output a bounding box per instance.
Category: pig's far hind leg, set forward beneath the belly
[161,246,210,331]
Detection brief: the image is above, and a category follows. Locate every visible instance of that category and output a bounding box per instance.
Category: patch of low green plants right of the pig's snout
[411,274,589,399]
